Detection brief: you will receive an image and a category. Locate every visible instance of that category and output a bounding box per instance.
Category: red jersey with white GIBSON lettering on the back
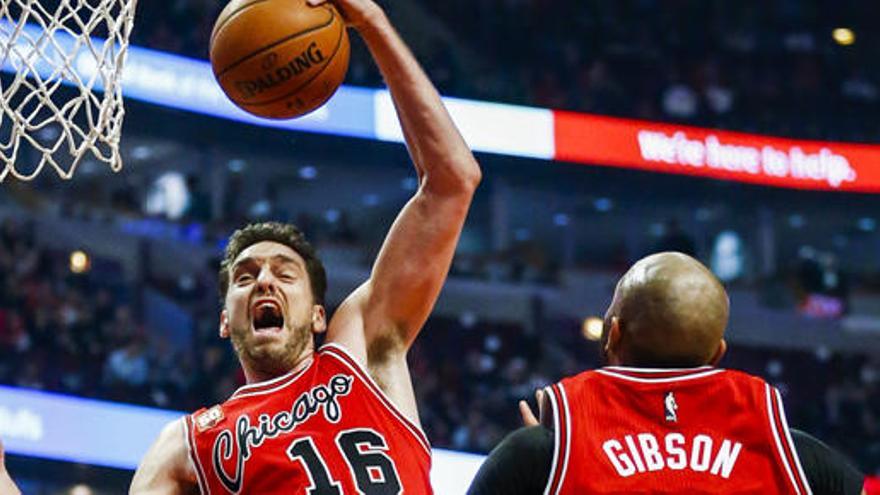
[544,366,811,495]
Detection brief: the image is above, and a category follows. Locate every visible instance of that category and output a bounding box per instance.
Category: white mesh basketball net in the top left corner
[0,0,137,182]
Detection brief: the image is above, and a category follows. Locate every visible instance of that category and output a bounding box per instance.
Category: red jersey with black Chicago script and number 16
[185,344,431,495]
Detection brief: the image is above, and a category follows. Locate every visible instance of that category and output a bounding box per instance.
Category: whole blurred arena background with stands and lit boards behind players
[0,0,880,495]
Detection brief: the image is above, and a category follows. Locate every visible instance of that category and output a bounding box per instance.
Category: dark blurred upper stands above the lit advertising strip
[133,0,880,141]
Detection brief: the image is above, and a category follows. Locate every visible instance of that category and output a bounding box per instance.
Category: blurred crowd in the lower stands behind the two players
[0,221,880,472]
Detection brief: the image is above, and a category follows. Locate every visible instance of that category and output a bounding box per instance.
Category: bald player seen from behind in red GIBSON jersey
[469,253,864,495]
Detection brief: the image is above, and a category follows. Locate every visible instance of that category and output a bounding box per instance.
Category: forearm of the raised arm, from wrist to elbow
[359,9,481,196]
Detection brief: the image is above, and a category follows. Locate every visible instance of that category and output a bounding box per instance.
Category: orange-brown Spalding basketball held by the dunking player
[210,0,350,119]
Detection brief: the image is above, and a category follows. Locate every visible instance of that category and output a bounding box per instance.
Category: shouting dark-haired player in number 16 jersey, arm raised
[131,0,481,495]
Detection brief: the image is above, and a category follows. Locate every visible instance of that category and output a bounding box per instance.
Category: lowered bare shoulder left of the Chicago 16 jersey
[129,419,198,495]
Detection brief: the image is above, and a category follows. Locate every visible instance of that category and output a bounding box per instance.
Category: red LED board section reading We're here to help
[554,112,880,192]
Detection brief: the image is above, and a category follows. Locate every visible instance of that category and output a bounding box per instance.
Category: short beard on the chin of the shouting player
[230,323,313,377]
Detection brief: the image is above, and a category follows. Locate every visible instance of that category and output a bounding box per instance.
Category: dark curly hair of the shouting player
[220,222,327,305]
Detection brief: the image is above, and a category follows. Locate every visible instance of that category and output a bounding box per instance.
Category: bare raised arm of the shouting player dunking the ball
[310,0,481,356]
